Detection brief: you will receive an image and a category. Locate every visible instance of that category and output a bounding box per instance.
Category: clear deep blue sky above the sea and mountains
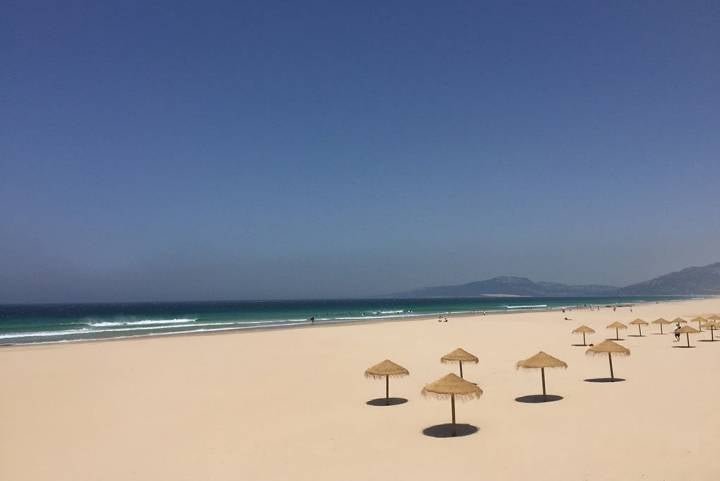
[0,0,720,302]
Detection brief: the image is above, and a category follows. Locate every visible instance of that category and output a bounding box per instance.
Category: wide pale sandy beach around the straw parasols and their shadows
[0,299,720,481]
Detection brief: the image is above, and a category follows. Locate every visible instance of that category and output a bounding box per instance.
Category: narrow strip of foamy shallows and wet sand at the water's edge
[0,296,696,349]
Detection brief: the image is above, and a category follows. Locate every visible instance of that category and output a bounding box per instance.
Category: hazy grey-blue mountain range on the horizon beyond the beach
[394,262,720,297]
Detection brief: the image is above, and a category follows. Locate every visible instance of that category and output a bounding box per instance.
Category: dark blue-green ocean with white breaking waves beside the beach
[0,297,678,345]
